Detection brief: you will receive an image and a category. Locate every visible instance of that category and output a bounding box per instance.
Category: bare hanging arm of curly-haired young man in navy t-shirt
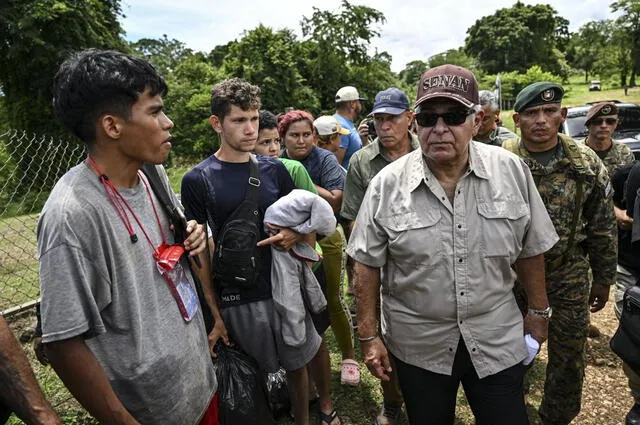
[189,238,229,358]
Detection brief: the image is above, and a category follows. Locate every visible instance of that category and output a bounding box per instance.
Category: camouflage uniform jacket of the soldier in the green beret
[503,134,617,285]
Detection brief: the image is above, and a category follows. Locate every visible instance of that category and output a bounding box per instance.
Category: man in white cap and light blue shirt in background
[333,86,367,169]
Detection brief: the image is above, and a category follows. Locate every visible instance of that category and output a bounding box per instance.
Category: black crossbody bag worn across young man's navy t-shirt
[205,154,262,289]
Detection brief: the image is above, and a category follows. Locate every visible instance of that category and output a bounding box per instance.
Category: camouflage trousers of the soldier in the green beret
[514,265,590,425]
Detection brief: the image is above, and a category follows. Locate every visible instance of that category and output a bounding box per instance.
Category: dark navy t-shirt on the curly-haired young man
[181,155,295,307]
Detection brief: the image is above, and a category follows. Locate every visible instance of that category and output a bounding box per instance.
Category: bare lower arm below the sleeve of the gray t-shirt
[45,336,139,425]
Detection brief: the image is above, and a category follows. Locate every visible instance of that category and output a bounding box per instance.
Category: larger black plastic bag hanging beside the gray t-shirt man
[214,344,275,425]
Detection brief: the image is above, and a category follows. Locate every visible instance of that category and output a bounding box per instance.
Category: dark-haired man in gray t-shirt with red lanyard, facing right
[38,50,220,425]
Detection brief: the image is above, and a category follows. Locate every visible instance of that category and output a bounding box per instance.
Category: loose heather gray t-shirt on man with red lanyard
[38,164,217,425]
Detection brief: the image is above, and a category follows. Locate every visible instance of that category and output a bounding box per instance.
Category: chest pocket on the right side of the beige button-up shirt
[477,200,530,256]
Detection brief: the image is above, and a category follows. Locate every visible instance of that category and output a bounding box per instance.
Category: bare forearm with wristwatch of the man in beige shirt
[516,254,549,344]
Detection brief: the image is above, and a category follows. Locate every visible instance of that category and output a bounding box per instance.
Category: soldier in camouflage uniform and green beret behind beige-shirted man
[503,83,617,425]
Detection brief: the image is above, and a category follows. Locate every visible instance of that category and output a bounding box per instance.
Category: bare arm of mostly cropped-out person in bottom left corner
[0,316,62,425]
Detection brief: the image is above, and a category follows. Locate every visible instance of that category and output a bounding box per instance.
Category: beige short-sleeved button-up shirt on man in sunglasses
[348,142,558,378]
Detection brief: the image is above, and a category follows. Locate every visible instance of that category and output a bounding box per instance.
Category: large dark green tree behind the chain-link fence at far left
[0,0,126,187]
